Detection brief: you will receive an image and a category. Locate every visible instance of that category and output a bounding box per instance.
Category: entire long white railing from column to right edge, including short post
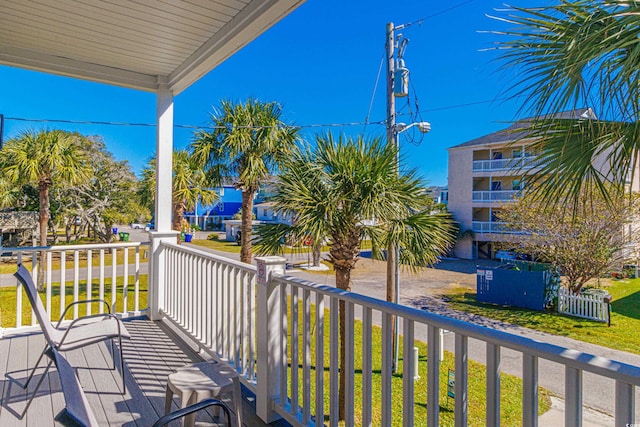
[155,243,640,427]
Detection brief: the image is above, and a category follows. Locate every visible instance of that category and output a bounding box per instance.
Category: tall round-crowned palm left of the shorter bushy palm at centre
[191,99,298,263]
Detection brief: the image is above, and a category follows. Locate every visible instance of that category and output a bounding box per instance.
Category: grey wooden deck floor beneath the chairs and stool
[0,319,283,427]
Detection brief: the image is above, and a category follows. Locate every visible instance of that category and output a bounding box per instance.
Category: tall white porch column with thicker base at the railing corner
[149,77,178,320]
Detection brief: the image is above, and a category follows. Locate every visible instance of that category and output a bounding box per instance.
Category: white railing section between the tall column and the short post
[161,243,256,386]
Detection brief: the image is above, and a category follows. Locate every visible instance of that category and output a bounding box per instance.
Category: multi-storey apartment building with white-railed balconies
[448,108,606,259]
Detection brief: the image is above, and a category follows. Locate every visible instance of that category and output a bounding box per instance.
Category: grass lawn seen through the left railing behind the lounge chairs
[0,274,147,328]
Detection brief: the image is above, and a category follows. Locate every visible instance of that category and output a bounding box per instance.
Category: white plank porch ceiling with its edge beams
[0,0,304,94]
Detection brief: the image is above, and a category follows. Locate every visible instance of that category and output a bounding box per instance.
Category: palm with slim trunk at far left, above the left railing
[0,130,91,249]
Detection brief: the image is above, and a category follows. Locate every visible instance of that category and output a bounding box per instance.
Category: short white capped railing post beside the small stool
[255,256,287,423]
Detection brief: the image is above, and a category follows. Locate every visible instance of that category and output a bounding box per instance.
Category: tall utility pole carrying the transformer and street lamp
[386,22,399,373]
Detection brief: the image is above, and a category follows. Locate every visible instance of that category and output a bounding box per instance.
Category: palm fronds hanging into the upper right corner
[498,0,640,201]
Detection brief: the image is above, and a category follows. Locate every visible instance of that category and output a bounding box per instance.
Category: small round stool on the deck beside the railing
[164,362,242,427]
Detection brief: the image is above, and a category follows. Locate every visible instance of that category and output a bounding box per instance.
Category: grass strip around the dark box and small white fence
[446,279,640,354]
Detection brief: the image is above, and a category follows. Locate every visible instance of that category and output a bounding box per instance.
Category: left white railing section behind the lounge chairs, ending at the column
[0,242,148,331]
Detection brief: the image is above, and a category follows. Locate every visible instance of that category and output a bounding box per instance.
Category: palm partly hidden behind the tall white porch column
[140,150,218,237]
